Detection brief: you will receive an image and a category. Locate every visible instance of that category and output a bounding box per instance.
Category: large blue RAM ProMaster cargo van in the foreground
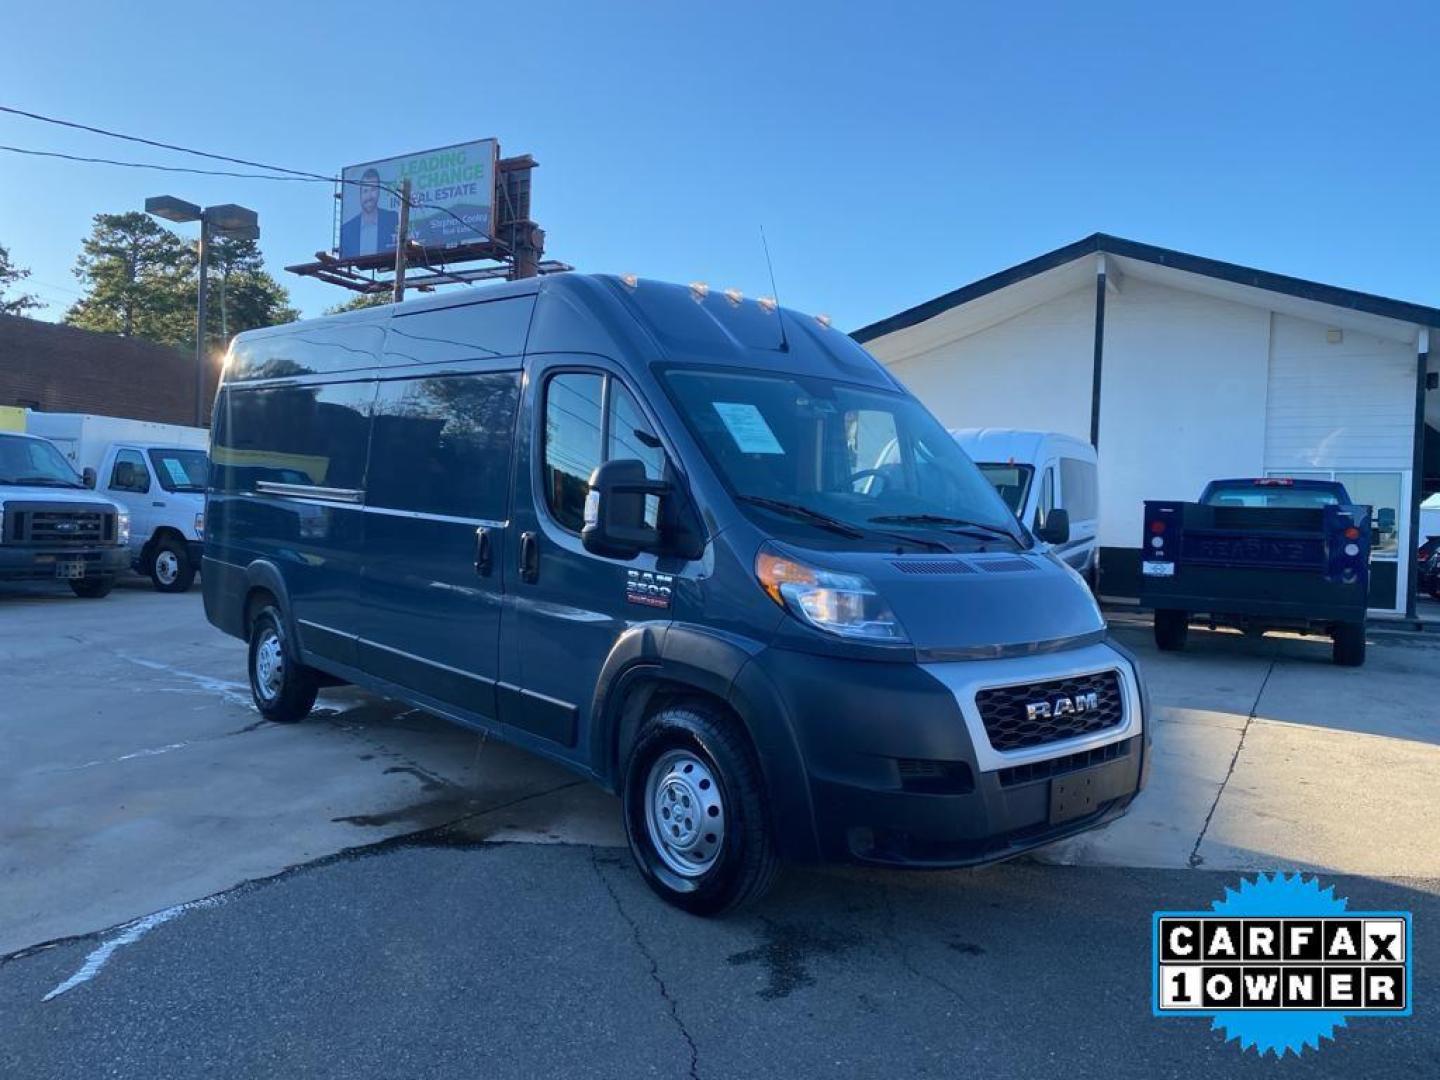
[203,274,1148,913]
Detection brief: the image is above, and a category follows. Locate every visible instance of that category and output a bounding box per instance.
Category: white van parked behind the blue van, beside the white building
[950,428,1100,582]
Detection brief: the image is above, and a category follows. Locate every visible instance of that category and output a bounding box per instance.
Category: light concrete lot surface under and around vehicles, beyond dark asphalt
[0,583,1440,955]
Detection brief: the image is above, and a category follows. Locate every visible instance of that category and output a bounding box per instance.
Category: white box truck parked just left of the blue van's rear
[27,412,210,592]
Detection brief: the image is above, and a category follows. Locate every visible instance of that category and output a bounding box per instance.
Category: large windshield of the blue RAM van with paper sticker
[665,369,1030,547]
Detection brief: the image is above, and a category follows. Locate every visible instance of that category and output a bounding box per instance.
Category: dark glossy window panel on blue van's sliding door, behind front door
[366,372,520,521]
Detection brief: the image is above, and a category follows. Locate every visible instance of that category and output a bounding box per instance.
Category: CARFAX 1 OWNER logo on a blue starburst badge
[1151,874,1413,1057]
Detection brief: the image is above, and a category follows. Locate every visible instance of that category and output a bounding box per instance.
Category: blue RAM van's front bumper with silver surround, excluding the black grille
[756,645,1149,868]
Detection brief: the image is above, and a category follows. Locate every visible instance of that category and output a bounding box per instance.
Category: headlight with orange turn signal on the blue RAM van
[755,546,909,644]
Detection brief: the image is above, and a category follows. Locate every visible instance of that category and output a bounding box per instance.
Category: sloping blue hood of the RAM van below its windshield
[811,550,1104,660]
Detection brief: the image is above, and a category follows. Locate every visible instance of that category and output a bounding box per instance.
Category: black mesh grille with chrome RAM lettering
[975,671,1125,750]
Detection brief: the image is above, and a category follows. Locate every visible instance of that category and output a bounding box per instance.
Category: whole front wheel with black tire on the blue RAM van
[622,701,779,914]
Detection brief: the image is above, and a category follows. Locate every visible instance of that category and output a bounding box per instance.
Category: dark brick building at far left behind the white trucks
[0,315,219,423]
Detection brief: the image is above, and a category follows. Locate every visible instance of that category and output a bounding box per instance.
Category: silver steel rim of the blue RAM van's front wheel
[645,750,726,877]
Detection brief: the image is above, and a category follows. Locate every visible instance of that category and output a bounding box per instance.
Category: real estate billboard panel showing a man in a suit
[338,138,500,259]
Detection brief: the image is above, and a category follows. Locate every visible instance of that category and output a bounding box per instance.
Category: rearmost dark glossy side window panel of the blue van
[210,382,374,492]
